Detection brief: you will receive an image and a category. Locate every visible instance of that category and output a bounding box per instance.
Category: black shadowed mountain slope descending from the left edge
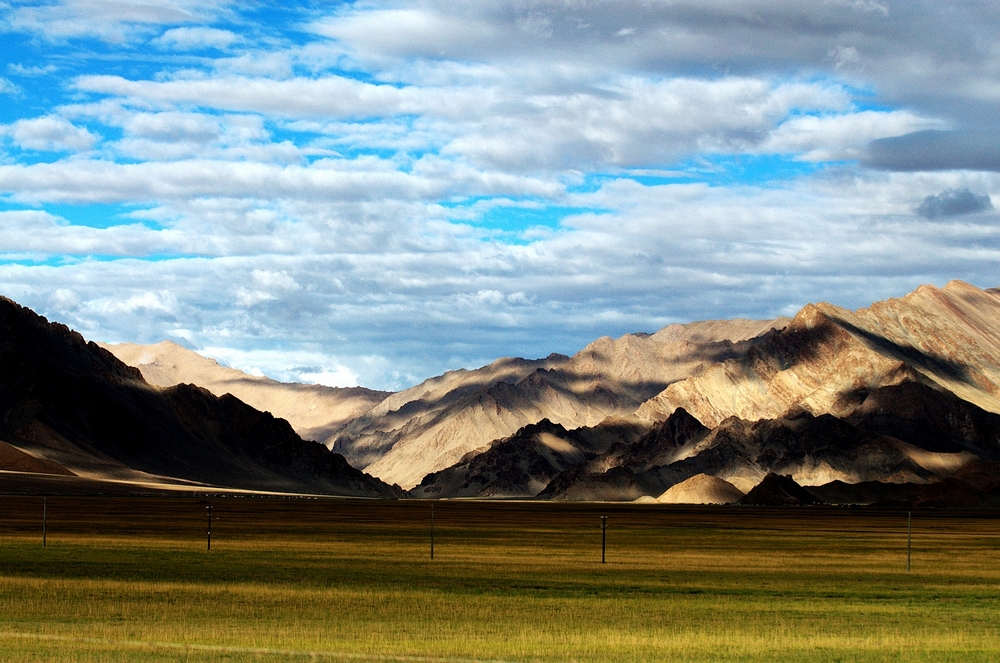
[0,298,402,497]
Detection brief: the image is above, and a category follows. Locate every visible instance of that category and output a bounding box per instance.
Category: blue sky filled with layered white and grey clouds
[0,0,1000,390]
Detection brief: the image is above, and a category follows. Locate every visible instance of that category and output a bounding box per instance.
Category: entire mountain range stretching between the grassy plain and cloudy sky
[0,281,1000,505]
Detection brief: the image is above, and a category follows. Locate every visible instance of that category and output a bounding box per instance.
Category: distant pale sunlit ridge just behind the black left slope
[98,341,391,440]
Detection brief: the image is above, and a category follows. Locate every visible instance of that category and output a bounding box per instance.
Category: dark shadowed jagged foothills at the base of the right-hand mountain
[520,376,1000,499]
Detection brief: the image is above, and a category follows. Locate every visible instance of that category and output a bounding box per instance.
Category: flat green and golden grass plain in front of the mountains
[0,497,1000,661]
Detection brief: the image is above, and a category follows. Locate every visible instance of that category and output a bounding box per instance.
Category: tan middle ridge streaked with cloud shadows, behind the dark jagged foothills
[332,319,787,487]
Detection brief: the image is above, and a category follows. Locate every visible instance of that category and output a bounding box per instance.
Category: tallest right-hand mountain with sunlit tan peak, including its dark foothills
[422,282,1000,502]
